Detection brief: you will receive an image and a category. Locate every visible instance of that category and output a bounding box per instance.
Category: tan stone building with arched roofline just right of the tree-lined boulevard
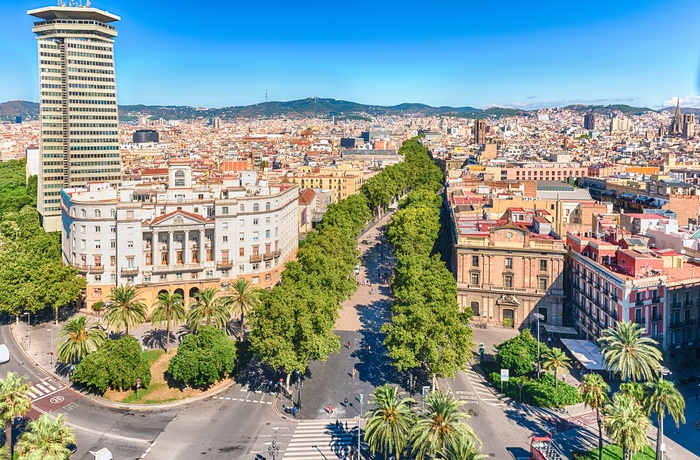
[452,215,566,328]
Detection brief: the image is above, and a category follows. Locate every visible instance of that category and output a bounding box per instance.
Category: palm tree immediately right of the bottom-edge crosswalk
[365,384,415,460]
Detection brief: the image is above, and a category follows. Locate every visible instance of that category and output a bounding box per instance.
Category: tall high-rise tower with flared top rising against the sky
[27,0,121,231]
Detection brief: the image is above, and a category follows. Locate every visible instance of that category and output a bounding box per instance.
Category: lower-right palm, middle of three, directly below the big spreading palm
[603,393,651,460]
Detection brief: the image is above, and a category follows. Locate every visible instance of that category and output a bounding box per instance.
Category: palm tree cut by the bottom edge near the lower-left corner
[17,414,77,460]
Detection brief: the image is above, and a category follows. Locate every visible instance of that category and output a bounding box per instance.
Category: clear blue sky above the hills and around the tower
[0,0,700,108]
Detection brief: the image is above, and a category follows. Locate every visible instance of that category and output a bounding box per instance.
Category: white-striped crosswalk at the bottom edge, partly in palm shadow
[282,418,364,460]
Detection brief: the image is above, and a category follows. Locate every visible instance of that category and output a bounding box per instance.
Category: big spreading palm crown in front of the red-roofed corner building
[598,321,661,380]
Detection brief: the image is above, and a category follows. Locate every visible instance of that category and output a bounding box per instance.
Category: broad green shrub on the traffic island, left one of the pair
[73,335,151,395]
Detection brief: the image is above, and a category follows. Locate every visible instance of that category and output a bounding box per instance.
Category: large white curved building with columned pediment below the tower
[62,160,299,306]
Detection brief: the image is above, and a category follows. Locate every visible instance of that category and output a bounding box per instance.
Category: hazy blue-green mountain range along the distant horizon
[0,97,700,122]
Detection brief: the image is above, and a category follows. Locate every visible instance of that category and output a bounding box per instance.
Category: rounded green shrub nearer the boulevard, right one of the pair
[168,326,236,387]
